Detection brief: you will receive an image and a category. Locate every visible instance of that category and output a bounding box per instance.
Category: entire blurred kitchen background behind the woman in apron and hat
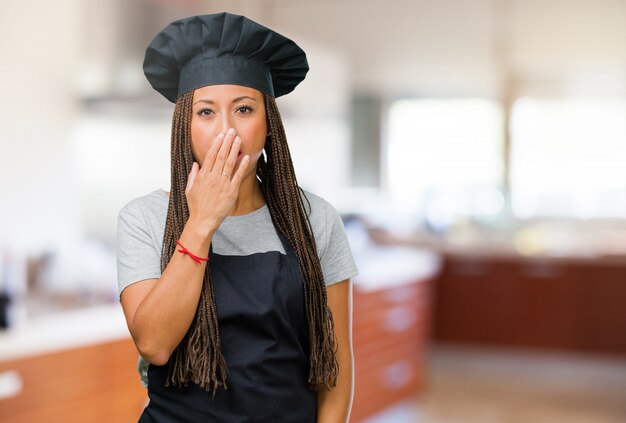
[0,0,626,423]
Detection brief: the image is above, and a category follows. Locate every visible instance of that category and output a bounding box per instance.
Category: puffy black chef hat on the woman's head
[143,13,309,102]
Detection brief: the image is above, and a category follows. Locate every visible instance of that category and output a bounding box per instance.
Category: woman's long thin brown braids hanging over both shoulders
[161,91,339,396]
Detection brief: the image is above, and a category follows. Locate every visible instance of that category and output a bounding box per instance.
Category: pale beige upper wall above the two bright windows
[206,0,626,96]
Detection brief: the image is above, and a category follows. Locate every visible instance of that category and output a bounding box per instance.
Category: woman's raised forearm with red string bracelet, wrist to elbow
[129,220,213,365]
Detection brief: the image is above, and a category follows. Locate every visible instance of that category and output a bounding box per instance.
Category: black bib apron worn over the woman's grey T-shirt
[139,230,317,423]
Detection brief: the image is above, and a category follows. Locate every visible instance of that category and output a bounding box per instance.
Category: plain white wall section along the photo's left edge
[0,0,80,251]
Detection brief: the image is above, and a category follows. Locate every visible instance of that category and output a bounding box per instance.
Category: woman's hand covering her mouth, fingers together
[185,128,250,232]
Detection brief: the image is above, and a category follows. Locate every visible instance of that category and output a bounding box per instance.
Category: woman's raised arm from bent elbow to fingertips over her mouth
[121,130,250,366]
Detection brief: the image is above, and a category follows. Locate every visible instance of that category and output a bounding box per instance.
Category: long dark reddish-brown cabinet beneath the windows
[434,255,626,354]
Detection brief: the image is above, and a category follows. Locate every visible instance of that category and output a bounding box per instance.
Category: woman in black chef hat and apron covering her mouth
[117,13,357,422]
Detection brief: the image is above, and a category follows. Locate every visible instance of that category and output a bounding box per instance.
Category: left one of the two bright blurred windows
[385,99,504,229]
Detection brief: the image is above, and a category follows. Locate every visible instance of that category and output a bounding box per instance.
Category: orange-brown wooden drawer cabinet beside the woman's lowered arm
[351,281,431,422]
